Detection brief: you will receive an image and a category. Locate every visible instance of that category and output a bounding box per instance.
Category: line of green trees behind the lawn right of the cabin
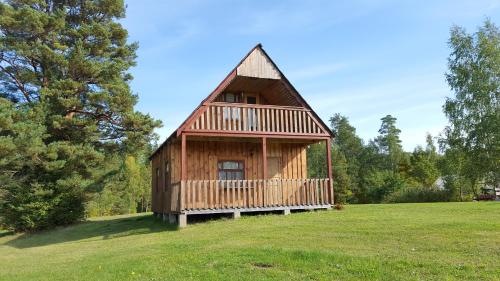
[308,20,500,203]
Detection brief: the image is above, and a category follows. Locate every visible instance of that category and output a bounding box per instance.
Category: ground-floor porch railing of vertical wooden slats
[173,179,333,211]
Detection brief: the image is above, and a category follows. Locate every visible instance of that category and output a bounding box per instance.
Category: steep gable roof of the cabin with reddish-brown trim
[151,43,334,156]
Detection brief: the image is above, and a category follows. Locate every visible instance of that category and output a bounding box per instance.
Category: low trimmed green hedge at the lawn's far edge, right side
[384,187,449,203]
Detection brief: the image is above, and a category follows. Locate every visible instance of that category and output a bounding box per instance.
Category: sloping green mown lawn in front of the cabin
[0,202,500,280]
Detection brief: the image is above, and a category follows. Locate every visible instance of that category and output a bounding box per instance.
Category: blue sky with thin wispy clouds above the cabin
[122,0,500,151]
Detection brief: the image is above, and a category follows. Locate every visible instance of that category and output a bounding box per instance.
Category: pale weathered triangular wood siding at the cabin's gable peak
[236,48,281,79]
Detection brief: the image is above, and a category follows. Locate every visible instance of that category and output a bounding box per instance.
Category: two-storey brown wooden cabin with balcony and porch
[150,44,334,227]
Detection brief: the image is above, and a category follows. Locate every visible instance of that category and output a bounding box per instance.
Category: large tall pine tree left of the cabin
[0,0,160,230]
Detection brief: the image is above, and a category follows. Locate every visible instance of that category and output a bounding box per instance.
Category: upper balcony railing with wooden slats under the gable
[188,103,327,134]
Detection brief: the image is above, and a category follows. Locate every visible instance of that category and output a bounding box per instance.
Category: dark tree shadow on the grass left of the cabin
[4,212,177,249]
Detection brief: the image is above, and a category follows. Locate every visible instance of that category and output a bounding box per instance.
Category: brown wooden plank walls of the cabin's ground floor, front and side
[151,137,307,213]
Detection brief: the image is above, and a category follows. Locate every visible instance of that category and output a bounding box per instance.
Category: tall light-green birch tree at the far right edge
[441,20,500,197]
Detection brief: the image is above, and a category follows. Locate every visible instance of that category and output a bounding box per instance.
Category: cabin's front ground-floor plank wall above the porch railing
[186,141,307,180]
